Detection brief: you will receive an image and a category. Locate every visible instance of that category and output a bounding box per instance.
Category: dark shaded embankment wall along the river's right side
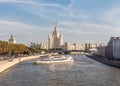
[86,55,120,68]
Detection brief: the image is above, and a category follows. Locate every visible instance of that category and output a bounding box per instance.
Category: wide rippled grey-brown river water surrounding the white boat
[0,55,120,86]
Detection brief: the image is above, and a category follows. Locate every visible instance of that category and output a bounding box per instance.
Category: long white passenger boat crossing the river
[34,56,74,64]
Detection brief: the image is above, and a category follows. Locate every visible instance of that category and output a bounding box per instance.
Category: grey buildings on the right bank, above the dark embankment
[97,37,120,59]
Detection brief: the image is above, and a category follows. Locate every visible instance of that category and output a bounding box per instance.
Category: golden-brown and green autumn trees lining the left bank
[0,41,36,55]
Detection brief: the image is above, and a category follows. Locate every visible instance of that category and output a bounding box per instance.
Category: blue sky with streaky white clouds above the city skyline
[0,0,120,45]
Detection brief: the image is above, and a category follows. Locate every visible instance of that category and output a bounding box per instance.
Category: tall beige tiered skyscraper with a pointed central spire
[48,24,63,49]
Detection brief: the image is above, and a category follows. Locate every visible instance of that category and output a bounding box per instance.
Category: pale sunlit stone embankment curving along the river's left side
[0,55,44,73]
